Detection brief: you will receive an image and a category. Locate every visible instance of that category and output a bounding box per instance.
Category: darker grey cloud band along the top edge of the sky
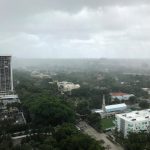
[0,0,150,21]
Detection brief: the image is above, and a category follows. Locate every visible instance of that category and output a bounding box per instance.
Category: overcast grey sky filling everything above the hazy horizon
[0,0,150,58]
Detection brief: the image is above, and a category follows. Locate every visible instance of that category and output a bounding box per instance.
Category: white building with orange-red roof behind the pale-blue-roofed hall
[110,92,135,101]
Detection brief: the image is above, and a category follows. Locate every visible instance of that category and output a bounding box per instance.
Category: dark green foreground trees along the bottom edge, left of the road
[0,124,104,150]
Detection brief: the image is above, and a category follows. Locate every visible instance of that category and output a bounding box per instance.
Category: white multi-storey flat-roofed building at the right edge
[116,109,150,137]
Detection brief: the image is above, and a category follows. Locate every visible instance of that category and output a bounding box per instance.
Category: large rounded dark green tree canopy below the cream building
[31,99,75,126]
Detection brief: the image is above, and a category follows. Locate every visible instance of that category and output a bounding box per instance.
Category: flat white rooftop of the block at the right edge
[116,109,150,122]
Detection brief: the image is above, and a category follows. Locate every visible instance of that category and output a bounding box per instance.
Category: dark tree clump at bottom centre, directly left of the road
[54,124,104,150]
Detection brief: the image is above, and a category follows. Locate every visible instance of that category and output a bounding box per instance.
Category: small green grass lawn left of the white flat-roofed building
[101,118,114,129]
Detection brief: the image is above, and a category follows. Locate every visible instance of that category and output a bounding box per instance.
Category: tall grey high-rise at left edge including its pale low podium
[0,55,20,106]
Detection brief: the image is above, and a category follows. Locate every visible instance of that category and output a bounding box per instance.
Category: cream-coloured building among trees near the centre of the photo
[57,81,80,92]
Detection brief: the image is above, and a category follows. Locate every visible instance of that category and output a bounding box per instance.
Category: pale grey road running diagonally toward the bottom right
[78,121,123,150]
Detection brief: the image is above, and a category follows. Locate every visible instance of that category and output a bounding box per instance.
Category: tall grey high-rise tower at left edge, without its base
[0,56,13,95]
